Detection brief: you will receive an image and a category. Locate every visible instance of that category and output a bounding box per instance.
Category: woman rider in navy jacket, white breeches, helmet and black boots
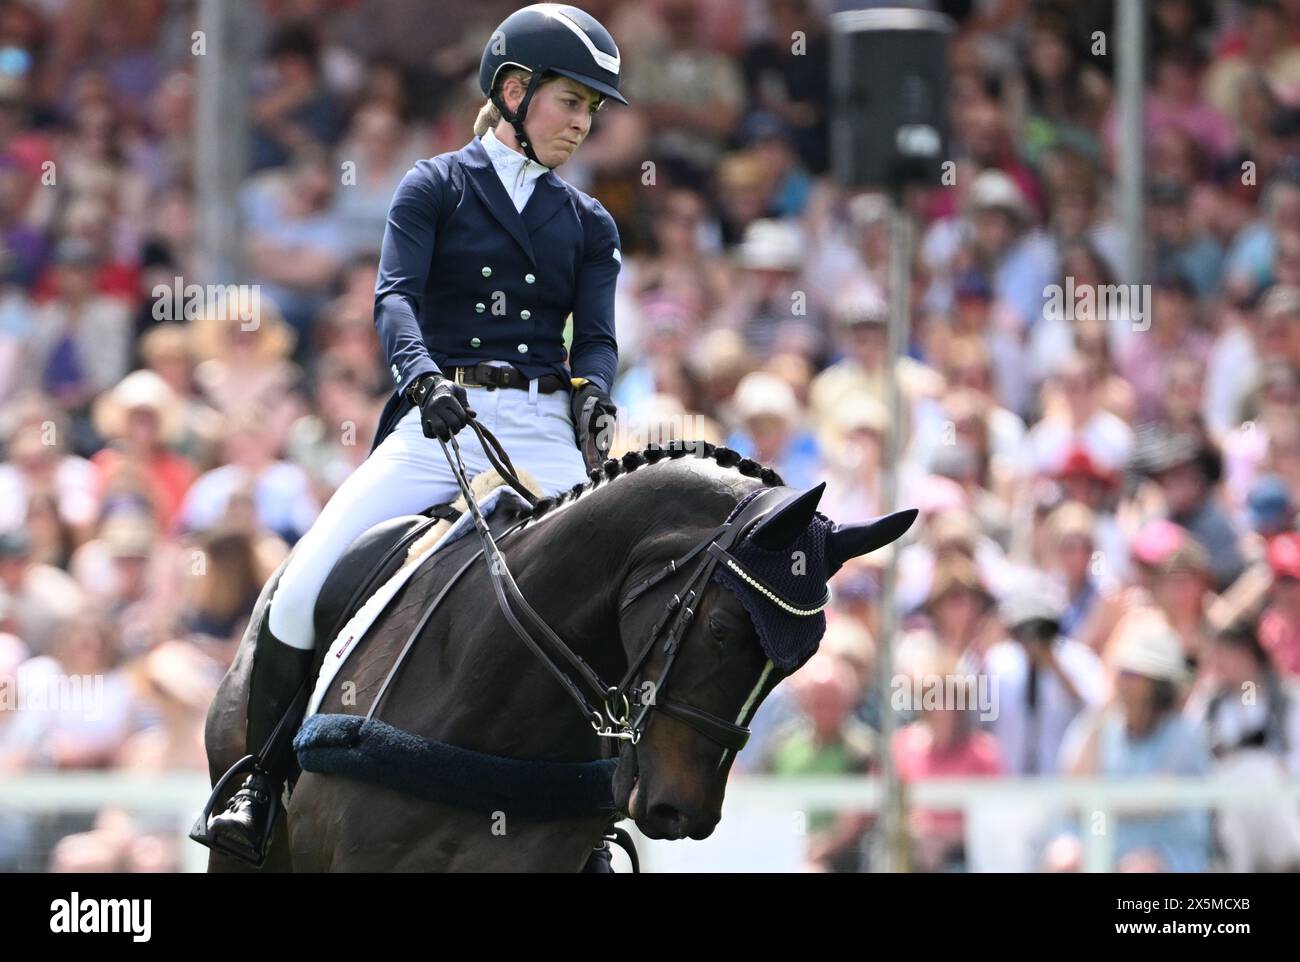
[192,4,627,865]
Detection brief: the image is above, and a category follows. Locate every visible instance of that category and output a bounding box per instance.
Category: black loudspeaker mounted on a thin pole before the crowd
[831,8,953,190]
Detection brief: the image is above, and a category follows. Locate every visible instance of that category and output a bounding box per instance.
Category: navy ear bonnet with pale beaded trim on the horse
[711,489,833,672]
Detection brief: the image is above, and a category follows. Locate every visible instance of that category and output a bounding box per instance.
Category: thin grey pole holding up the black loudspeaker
[876,195,911,872]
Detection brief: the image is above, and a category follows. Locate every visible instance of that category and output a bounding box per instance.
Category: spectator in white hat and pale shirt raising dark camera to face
[982,576,1106,775]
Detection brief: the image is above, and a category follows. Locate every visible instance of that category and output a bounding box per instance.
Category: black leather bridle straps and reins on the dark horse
[441,425,829,754]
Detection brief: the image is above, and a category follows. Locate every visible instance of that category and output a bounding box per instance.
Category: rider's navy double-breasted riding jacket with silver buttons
[372,137,623,450]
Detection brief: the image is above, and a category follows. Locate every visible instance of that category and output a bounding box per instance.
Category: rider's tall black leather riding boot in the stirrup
[190,612,313,866]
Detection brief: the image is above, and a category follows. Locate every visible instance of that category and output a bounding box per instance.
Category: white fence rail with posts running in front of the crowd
[0,772,1300,871]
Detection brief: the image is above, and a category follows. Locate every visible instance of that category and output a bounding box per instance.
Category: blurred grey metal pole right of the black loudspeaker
[1115,0,1147,283]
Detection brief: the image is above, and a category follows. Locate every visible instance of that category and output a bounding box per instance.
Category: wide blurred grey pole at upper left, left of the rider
[194,0,252,283]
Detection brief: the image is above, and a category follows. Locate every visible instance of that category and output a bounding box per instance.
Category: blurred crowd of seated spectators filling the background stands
[0,0,1300,871]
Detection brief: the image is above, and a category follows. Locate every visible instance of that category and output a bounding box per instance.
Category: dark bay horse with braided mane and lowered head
[208,445,915,871]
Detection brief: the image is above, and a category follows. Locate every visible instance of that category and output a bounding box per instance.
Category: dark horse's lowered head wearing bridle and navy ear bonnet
[614,485,917,839]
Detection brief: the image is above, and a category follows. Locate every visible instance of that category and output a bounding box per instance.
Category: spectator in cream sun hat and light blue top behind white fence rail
[1044,614,1210,872]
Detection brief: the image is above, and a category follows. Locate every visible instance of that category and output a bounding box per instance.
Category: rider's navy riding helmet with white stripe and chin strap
[478,4,628,164]
